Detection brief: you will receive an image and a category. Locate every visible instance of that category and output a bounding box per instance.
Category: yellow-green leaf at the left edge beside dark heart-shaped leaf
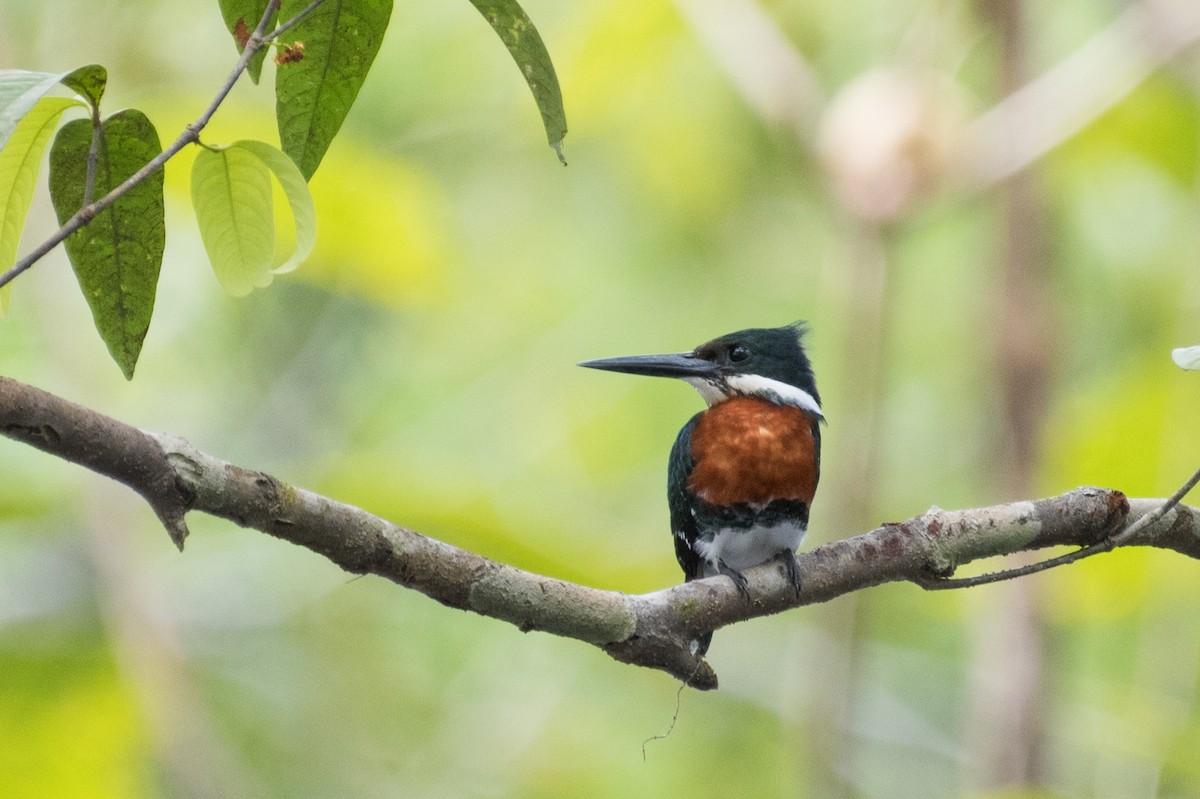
[0,97,83,316]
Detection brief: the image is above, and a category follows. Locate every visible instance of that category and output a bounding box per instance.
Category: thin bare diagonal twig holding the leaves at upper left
[0,0,324,286]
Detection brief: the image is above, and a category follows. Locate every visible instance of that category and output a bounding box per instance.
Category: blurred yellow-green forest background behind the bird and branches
[0,0,1200,799]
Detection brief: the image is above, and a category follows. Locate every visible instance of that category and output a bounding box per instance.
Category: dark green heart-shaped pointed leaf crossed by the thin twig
[50,109,166,379]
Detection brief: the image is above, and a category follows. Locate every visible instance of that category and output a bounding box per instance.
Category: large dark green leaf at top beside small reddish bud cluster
[275,0,391,180]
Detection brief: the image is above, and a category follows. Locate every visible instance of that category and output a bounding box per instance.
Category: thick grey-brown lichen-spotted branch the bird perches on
[0,369,1200,689]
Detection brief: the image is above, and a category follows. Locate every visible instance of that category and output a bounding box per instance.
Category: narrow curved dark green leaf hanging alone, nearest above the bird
[470,0,566,161]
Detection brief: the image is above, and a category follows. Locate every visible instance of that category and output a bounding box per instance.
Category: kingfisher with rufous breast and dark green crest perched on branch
[580,322,824,655]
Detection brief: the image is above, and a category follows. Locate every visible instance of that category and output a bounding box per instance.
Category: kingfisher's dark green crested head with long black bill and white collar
[580,322,824,419]
